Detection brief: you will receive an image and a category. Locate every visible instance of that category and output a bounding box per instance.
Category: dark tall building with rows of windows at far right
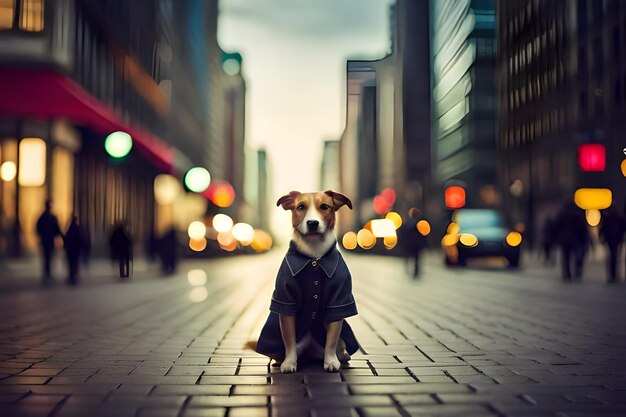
[498,0,626,240]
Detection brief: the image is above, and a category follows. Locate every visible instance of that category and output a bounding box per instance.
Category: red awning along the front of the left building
[0,68,174,172]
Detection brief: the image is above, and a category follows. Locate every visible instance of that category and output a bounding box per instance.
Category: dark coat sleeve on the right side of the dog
[324,259,358,322]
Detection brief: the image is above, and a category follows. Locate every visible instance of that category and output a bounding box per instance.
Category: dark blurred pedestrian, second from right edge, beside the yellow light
[556,202,589,281]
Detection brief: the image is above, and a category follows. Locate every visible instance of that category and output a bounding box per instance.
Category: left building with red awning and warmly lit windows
[0,0,221,254]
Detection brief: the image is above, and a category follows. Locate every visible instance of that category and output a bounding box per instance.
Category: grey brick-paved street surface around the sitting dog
[0,250,626,417]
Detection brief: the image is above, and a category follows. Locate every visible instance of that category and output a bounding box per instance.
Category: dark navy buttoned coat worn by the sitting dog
[257,242,359,360]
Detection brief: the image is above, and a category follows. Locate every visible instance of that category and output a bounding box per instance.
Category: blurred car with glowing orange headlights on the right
[441,209,522,268]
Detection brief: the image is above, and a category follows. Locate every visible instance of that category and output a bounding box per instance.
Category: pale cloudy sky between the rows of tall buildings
[218,0,393,237]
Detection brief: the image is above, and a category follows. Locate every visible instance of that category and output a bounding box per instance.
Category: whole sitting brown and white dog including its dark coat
[257,190,358,373]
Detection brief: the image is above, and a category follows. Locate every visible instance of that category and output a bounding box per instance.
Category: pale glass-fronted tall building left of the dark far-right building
[431,0,498,206]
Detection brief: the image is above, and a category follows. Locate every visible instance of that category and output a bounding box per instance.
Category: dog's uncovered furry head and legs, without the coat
[276,190,352,373]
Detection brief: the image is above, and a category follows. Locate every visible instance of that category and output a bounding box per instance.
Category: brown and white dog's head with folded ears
[276,190,352,241]
